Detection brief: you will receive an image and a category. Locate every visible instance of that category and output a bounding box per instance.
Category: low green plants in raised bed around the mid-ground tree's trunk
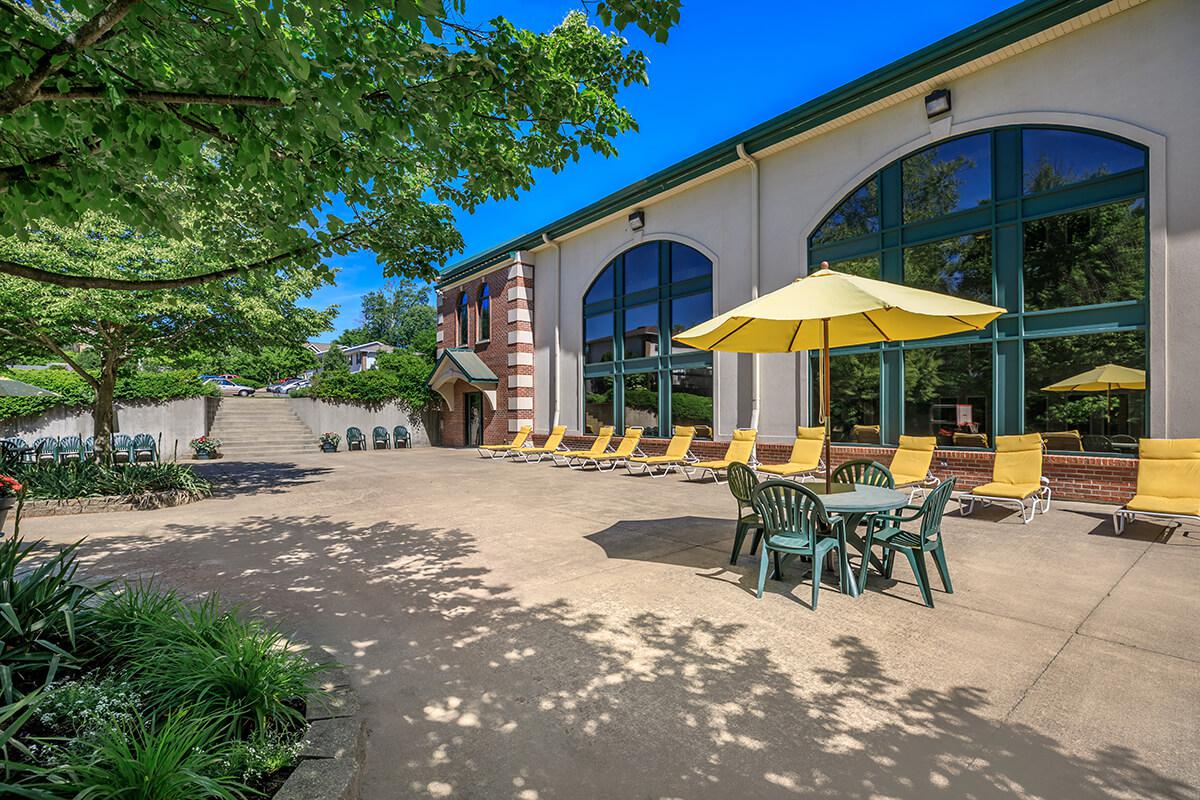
[8,462,212,500]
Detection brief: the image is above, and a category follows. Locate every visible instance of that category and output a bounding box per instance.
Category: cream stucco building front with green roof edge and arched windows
[439,0,1200,497]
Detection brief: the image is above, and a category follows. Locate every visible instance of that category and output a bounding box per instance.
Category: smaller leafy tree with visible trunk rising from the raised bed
[0,212,336,453]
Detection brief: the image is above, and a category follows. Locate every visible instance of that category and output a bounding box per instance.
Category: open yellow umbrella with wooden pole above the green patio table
[673,261,1004,492]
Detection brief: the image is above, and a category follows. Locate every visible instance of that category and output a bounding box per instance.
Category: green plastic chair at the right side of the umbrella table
[858,477,955,608]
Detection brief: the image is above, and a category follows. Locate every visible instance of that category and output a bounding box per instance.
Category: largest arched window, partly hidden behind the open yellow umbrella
[809,127,1148,455]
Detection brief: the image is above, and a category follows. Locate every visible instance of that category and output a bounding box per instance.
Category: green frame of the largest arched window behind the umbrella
[808,125,1151,456]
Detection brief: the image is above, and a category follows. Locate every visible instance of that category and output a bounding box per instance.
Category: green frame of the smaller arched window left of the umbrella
[581,239,715,437]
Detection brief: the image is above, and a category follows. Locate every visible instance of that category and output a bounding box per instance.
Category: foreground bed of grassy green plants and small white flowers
[0,536,329,800]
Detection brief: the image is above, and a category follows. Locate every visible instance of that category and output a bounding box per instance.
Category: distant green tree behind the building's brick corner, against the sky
[336,278,438,361]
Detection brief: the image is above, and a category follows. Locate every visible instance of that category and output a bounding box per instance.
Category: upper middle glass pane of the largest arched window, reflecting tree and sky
[901,133,991,223]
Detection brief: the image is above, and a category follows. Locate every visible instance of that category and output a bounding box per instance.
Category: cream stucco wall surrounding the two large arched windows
[534,0,1200,441]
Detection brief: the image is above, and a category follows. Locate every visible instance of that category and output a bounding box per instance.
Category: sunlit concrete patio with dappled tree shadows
[25,450,1200,800]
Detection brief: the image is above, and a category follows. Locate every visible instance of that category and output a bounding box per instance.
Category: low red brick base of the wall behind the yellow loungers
[549,437,1138,503]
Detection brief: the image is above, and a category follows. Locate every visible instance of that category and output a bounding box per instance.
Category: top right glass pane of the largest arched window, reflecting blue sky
[1021,128,1146,194]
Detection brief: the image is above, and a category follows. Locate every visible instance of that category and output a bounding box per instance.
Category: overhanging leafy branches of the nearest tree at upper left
[0,0,680,290]
